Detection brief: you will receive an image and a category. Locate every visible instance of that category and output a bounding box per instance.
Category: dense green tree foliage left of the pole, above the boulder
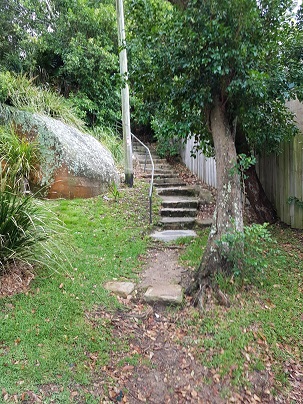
[0,0,121,126]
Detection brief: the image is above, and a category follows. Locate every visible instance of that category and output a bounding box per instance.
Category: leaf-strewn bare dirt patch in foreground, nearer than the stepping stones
[83,300,276,404]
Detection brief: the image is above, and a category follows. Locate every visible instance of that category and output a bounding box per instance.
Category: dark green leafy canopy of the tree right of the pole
[128,0,302,152]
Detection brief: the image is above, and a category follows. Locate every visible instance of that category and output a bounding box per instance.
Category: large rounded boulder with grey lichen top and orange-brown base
[7,111,119,198]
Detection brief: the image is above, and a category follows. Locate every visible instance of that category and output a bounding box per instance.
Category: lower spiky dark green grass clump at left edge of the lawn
[0,188,68,275]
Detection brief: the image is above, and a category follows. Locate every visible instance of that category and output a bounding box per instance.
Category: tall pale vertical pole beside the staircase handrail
[116,0,134,187]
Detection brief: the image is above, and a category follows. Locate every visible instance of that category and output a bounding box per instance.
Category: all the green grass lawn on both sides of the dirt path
[0,183,303,403]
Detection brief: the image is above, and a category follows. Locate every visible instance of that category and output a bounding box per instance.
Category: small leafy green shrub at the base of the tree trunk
[217,223,273,279]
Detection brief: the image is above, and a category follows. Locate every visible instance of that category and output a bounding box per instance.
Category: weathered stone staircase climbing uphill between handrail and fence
[133,142,209,230]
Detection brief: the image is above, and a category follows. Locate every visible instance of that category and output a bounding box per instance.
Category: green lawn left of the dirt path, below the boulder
[0,184,154,402]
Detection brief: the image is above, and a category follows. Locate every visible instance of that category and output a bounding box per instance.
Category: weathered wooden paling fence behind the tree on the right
[181,101,303,229]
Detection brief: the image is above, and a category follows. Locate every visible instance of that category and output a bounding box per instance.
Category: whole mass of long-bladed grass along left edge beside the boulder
[0,128,67,275]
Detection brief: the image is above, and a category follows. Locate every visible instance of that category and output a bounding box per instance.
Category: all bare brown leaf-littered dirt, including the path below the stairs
[0,160,303,404]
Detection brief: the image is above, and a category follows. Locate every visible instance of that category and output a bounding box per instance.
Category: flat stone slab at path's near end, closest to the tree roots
[143,284,183,304]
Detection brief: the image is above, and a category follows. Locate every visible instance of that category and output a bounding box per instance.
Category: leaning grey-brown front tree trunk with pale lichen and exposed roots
[188,99,243,303]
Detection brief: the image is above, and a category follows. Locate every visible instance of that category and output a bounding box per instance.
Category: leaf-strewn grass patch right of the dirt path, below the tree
[182,225,303,394]
